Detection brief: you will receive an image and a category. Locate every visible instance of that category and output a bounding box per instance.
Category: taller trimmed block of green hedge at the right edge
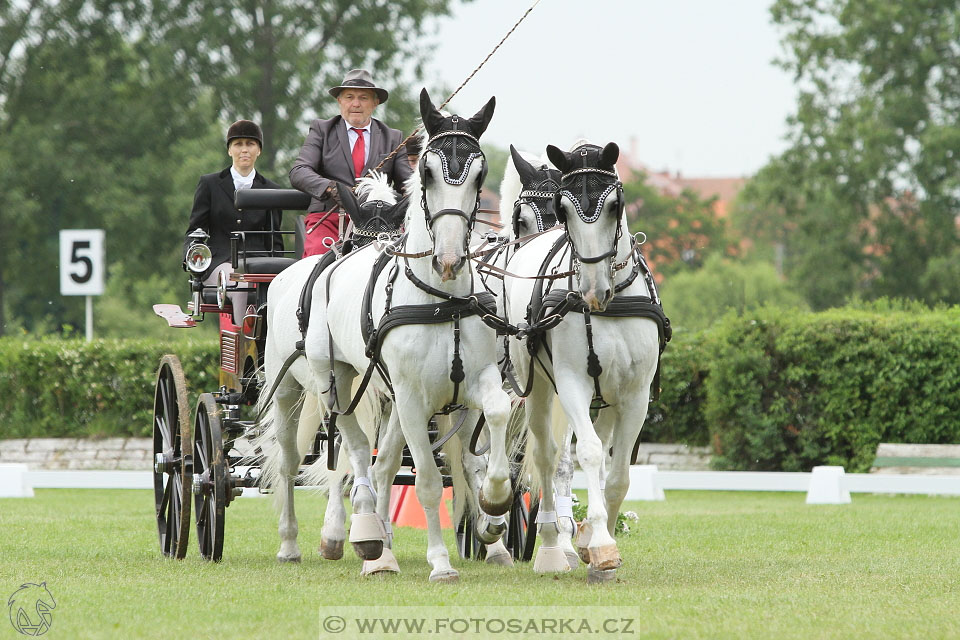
[703,308,960,472]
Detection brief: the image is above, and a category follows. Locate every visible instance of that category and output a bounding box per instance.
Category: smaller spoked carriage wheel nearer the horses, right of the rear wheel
[193,393,227,562]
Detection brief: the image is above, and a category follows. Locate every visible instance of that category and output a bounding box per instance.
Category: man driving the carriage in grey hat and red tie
[290,69,412,256]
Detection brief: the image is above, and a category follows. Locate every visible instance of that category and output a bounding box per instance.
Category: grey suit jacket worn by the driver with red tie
[290,116,413,212]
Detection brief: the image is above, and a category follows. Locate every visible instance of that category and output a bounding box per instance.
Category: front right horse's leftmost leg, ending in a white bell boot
[526,381,570,573]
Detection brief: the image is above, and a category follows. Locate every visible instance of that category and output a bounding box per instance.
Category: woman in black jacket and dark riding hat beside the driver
[183,120,283,325]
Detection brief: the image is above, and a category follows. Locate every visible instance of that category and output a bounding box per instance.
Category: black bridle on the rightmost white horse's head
[554,148,625,280]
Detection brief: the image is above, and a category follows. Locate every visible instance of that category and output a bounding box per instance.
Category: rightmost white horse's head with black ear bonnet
[547,142,624,311]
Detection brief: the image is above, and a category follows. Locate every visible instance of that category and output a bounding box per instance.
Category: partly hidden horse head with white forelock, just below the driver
[337,172,410,249]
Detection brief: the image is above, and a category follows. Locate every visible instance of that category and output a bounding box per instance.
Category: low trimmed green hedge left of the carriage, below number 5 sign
[0,338,219,438]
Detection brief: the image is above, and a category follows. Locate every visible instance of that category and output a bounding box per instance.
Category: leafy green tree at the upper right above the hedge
[734,0,960,308]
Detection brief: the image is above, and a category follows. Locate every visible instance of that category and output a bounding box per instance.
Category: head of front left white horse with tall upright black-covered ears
[419,89,496,282]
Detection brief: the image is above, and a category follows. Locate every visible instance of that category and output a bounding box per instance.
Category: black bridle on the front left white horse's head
[419,116,487,247]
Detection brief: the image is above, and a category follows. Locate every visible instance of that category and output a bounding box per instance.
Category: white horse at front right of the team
[506,143,660,580]
